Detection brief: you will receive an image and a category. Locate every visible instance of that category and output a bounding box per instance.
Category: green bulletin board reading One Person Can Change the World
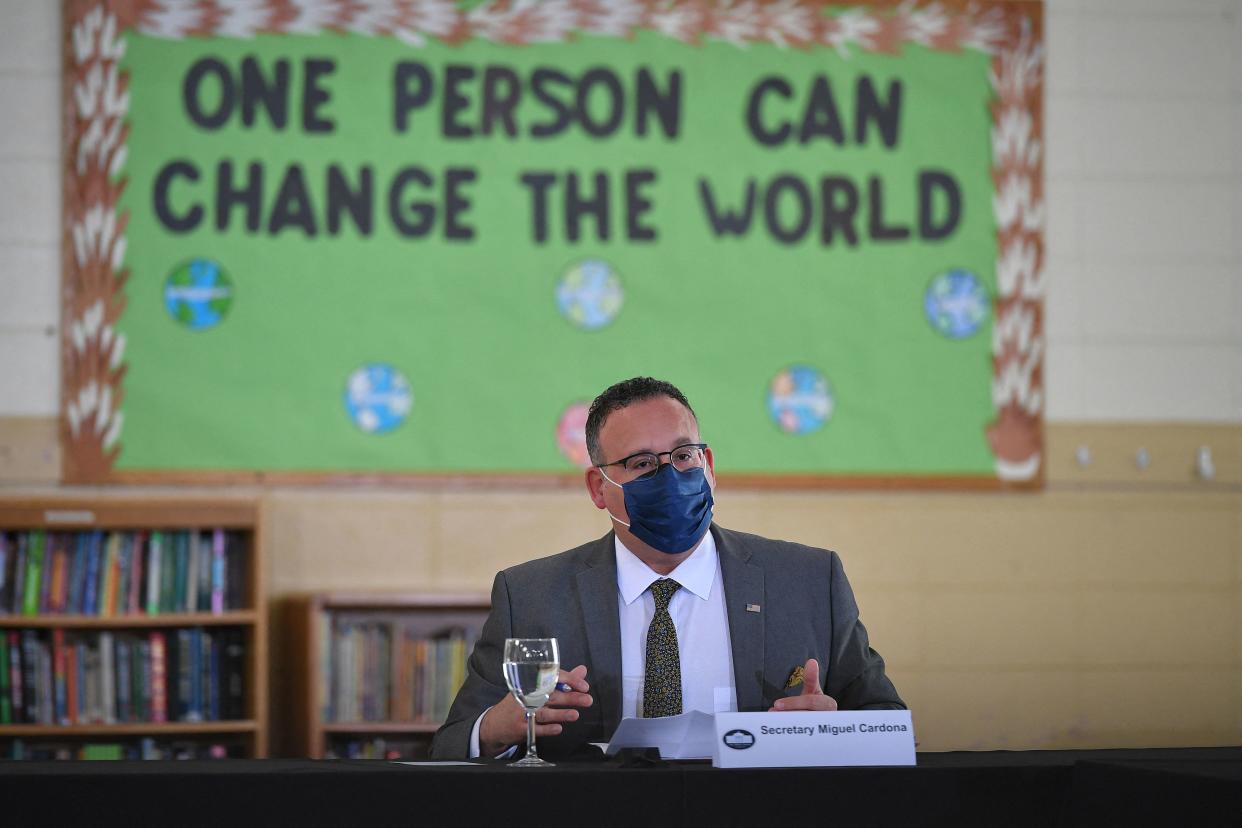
[62,0,1045,488]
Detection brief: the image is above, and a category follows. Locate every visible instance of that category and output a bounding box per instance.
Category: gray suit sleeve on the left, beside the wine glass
[431,572,513,760]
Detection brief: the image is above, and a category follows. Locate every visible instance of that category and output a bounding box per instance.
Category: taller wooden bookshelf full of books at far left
[0,495,268,758]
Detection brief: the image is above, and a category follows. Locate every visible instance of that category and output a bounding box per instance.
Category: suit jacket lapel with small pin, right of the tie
[712,525,764,711]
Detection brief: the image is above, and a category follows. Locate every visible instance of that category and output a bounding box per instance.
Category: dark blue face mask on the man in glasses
[610,463,715,555]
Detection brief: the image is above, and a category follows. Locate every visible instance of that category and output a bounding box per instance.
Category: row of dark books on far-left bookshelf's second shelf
[0,627,246,725]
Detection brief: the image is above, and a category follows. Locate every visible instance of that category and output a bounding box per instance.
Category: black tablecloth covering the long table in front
[0,747,1242,828]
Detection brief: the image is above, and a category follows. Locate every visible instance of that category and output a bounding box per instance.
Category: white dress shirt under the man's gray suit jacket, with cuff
[469,531,738,758]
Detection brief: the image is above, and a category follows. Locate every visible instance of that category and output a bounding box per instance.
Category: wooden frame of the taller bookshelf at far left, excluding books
[0,494,270,758]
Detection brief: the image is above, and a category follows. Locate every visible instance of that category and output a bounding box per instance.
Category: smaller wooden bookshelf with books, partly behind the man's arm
[284,592,491,758]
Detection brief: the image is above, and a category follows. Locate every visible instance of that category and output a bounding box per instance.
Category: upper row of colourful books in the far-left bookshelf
[0,529,246,617]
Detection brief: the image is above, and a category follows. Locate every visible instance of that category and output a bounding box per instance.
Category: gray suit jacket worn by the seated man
[431,524,905,758]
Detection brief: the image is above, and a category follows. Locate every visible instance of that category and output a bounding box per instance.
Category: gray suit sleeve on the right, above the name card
[823,552,905,710]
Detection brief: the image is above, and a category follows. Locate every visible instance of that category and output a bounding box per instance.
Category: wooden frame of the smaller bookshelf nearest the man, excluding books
[284,592,489,758]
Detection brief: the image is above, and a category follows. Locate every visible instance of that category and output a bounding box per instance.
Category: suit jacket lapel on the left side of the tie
[576,533,621,739]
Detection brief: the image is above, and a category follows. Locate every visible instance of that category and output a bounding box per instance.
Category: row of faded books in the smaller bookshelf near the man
[320,613,478,722]
